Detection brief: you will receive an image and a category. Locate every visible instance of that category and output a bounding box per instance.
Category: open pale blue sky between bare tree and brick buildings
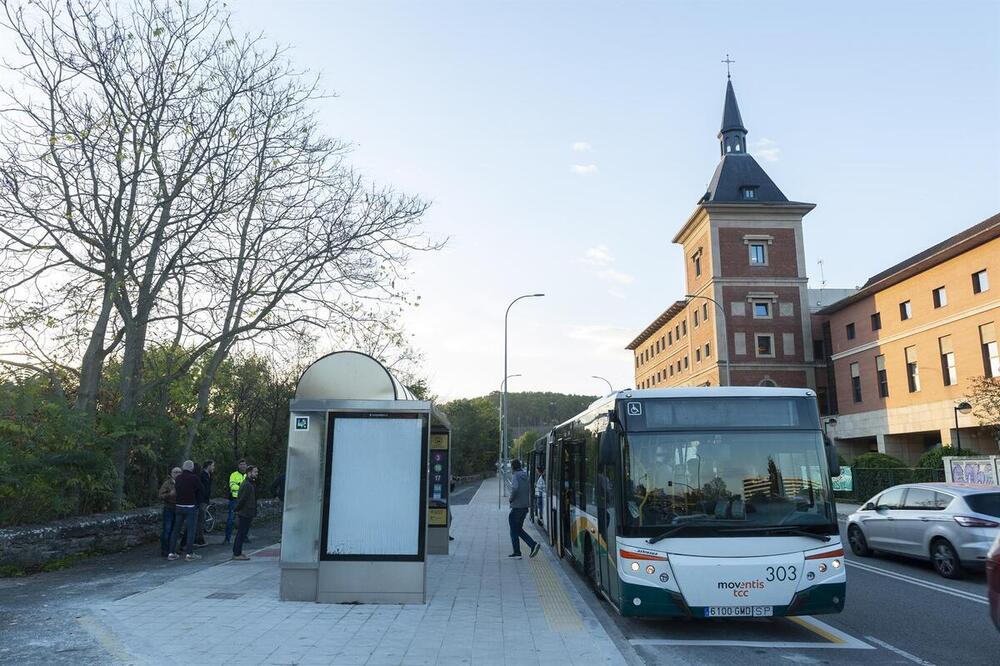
[230,0,1000,399]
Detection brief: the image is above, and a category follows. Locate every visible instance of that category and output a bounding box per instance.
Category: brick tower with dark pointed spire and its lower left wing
[627,77,816,388]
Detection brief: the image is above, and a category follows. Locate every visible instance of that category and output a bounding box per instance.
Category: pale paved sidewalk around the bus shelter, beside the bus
[90,479,625,666]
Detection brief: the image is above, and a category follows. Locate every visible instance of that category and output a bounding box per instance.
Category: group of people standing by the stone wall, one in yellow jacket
[159,460,268,562]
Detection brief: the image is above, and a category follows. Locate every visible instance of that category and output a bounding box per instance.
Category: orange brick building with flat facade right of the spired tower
[818,215,1000,463]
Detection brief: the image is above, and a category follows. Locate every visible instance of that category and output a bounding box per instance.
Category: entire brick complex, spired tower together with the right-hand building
[627,74,1000,456]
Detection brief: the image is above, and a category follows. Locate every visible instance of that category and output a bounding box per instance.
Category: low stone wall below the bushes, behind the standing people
[0,499,281,570]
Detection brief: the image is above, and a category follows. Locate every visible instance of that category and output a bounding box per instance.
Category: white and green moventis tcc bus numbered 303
[544,387,847,618]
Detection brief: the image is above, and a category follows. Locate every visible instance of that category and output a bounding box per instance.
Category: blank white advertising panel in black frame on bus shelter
[326,417,426,558]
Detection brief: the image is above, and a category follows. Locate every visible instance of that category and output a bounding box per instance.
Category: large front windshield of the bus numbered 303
[623,431,837,536]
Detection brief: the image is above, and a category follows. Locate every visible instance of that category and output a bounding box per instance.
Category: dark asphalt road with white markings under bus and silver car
[564,521,1000,666]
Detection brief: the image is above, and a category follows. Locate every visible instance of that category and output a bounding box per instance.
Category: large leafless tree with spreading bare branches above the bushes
[0,0,435,502]
